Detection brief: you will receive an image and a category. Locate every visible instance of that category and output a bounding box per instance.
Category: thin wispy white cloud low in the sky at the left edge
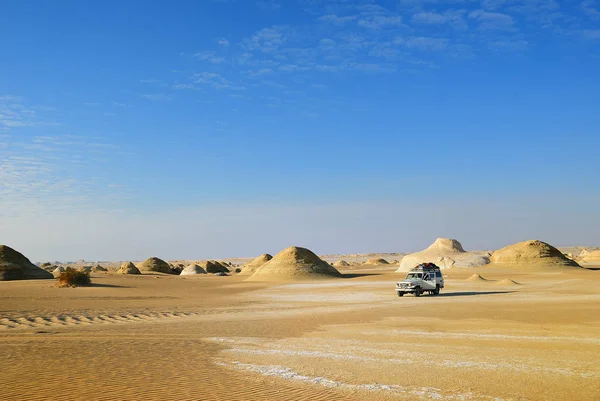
[0,130,131,219]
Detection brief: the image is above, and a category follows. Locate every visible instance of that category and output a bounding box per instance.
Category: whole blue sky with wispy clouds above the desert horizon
[0,0,600,260]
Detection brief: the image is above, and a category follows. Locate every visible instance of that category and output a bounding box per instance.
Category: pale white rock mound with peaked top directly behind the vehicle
[396,238,490,272]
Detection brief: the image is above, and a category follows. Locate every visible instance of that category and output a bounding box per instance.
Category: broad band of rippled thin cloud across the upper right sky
[136,0,597,115]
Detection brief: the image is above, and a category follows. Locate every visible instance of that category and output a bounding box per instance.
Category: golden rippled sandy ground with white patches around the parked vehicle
[0,267,600,401]
